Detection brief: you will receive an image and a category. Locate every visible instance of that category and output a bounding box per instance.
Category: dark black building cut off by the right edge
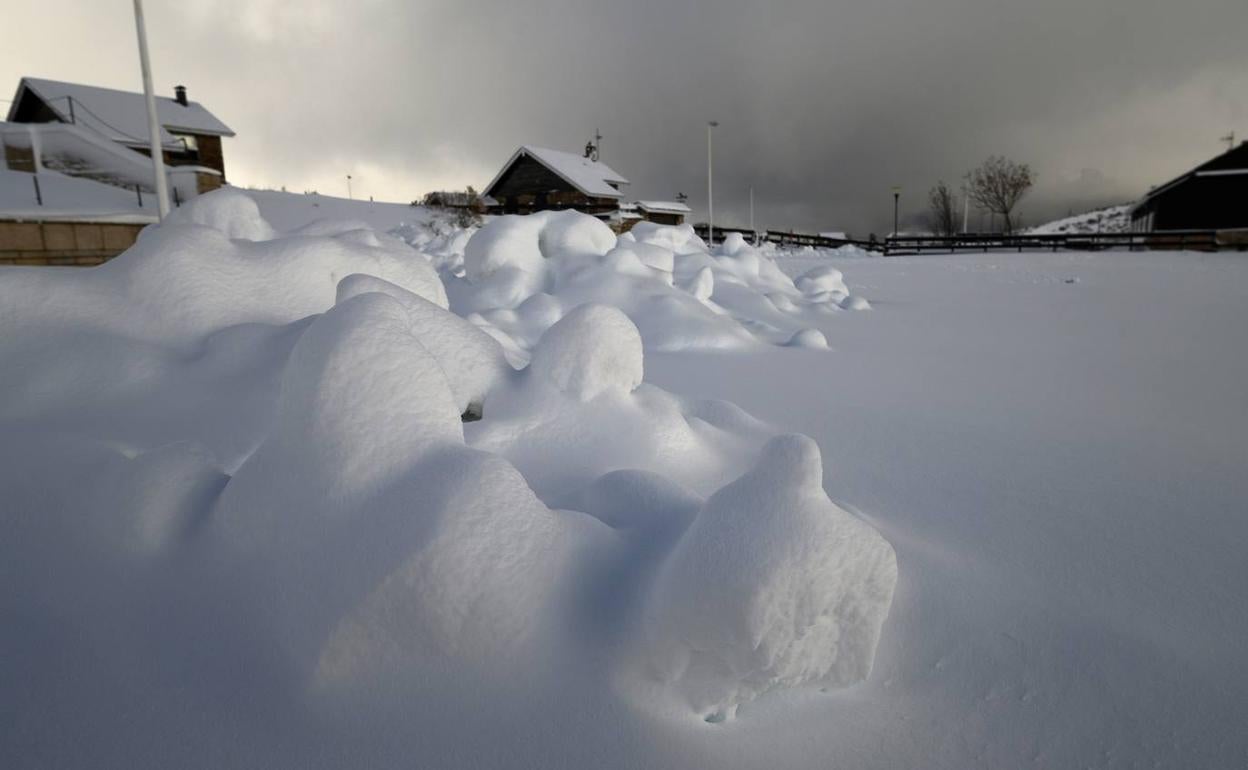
[1131,142,1248,232]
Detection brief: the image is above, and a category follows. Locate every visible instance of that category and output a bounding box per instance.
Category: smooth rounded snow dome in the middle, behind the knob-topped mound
[529,305,641,401]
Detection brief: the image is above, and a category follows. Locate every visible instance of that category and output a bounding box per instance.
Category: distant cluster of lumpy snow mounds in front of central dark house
[411,211,859,354]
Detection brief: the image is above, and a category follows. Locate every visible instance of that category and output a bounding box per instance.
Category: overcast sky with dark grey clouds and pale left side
[0,0,1248,235]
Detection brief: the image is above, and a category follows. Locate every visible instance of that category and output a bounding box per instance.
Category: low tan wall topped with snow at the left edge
[0,220,145,266]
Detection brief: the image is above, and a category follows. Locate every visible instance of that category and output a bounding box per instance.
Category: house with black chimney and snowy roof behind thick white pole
[6,77,235,192]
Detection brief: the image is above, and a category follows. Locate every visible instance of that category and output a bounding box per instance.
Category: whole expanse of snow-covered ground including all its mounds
[0,187,1248,769]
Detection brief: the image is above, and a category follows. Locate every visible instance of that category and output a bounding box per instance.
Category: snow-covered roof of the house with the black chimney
[9,77,235,145]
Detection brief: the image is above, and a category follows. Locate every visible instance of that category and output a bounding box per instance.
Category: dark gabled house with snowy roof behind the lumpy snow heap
[483,146,629,220]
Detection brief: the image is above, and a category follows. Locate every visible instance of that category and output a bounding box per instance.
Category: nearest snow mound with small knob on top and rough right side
[646,436,897,721]
